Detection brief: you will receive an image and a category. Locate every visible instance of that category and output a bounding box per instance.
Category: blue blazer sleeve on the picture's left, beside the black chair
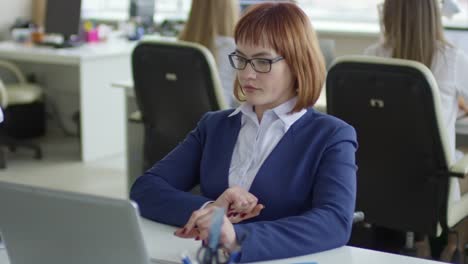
[130,114,210,226]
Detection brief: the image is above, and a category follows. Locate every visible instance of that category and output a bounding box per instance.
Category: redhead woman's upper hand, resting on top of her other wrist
[205,186,265,224]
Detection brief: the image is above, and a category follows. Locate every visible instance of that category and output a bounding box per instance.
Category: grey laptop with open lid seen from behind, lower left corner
[0,182,177,264]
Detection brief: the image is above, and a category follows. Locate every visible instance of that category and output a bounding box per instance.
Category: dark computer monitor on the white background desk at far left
[44,0,81,42]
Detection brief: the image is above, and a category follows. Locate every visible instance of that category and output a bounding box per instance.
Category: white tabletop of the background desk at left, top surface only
[0,39,137,65]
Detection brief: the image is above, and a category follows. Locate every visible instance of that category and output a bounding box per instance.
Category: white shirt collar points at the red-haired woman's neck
[228,97,307,130]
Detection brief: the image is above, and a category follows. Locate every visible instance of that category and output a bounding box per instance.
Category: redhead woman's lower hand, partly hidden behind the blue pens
[174,206,236,249]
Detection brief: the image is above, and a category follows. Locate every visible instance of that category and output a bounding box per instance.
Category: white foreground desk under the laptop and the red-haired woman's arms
[0,219,441,264]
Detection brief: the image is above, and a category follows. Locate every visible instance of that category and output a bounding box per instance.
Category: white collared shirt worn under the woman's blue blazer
[229,97,307,190]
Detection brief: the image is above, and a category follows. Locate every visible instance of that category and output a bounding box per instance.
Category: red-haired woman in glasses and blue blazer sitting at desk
[131,2,357,262]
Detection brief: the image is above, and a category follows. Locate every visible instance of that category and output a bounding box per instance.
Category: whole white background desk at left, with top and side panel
[0,40,135,162]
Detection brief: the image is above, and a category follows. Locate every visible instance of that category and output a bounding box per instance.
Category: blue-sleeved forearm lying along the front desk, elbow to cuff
[234,206,352,262]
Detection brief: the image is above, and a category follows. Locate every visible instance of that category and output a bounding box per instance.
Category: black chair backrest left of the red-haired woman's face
[132,40,226,169]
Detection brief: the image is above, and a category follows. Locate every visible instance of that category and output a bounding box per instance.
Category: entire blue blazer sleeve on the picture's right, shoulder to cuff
[234,126,357,262]
